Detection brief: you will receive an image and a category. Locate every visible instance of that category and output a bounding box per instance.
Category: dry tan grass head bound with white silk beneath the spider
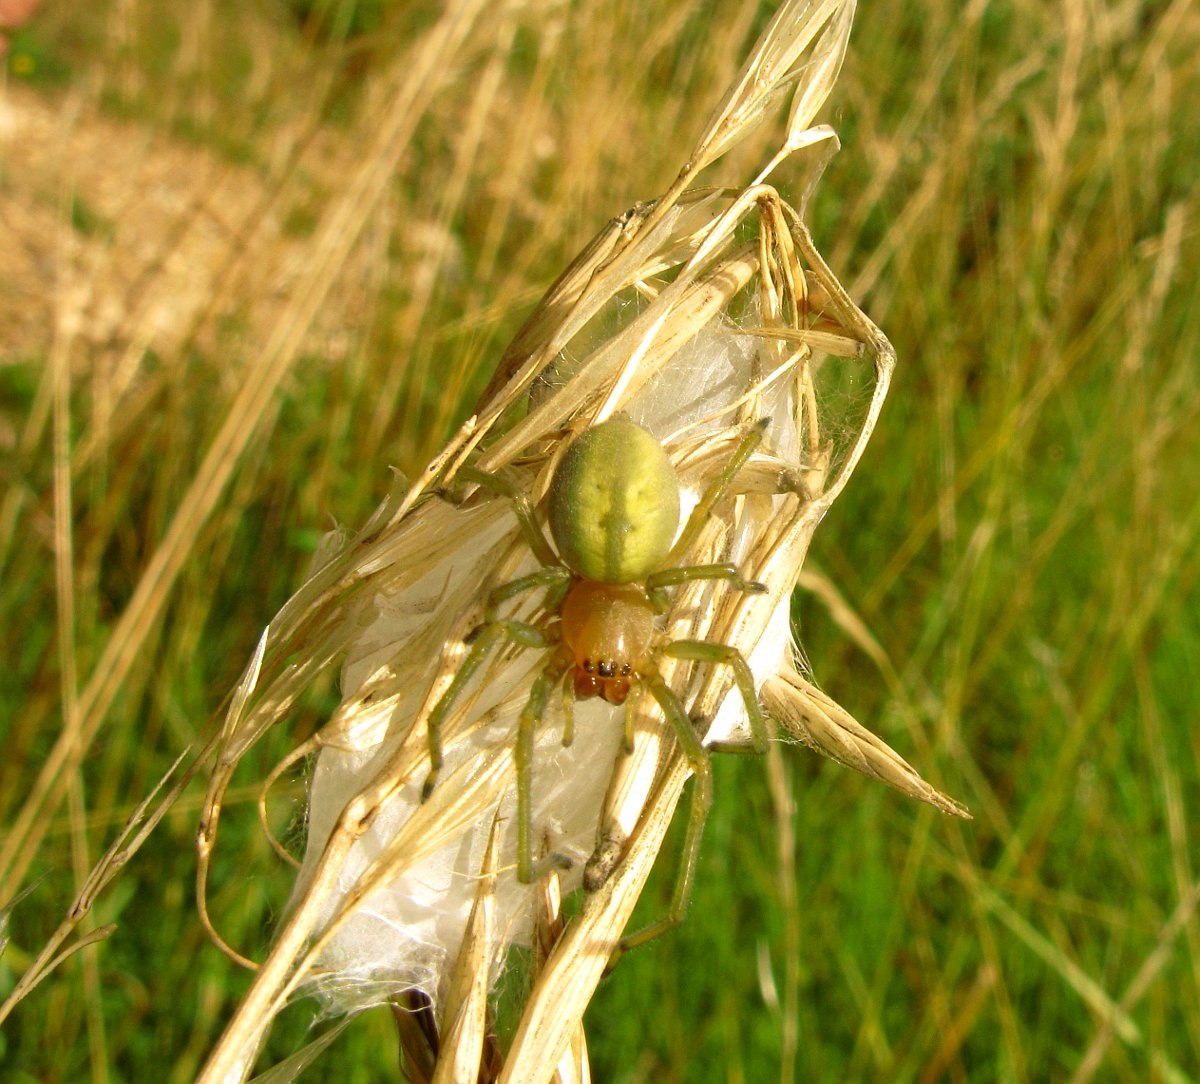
[189,0,961,1082]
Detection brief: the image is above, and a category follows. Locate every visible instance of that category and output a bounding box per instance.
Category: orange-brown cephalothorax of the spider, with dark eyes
[562,580,654,703]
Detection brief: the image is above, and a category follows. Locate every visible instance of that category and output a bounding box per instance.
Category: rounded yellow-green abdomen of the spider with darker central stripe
[550,417,679,583]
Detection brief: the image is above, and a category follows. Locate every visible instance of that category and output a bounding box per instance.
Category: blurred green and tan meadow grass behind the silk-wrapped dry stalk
[0,0,1200,1084]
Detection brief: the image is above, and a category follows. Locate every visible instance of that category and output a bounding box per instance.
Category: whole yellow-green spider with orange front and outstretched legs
[422,415,767,921]
